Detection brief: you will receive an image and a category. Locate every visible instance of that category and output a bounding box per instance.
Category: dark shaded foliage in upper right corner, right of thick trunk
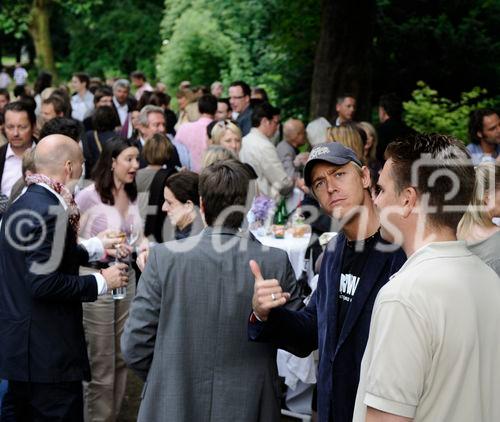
[373,0,500,100]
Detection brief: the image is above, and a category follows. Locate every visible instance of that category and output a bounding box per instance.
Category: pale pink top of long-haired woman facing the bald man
[75,184,143,239]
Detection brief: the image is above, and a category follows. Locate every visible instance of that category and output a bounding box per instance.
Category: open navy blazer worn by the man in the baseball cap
[248,233,406,422]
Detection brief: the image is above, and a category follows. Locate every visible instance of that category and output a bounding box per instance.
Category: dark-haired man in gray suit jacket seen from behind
[121,160,300,422]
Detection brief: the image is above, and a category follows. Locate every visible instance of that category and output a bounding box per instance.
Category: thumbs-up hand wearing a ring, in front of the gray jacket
[250,259,290,321]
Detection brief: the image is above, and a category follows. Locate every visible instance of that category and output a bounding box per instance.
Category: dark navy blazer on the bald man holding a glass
[0,185,97,383]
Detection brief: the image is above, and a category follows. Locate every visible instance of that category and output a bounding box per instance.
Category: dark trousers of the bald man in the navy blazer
[1,381,83,422]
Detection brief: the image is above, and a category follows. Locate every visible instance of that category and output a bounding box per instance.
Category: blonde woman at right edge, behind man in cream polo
[457,162,500,276]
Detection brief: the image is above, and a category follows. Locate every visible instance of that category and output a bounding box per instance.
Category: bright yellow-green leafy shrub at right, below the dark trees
[403,81,496,143]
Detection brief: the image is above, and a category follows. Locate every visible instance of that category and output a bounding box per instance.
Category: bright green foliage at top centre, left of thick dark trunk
[157,0,320,117]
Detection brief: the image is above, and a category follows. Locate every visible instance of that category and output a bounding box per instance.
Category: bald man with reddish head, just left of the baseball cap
[276,119,308,178]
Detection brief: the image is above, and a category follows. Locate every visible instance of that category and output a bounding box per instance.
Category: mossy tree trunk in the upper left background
[29,0,56,78]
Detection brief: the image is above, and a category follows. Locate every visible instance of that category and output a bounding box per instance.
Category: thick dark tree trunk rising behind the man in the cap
[311,0,375,121]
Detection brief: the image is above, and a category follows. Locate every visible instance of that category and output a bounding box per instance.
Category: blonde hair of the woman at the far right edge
[457,162,500,240]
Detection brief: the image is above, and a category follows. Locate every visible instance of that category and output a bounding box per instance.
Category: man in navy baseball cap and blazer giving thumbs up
[248,142,406,422]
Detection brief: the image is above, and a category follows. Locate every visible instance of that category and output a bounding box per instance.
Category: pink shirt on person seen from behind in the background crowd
[175,117,212,173]
